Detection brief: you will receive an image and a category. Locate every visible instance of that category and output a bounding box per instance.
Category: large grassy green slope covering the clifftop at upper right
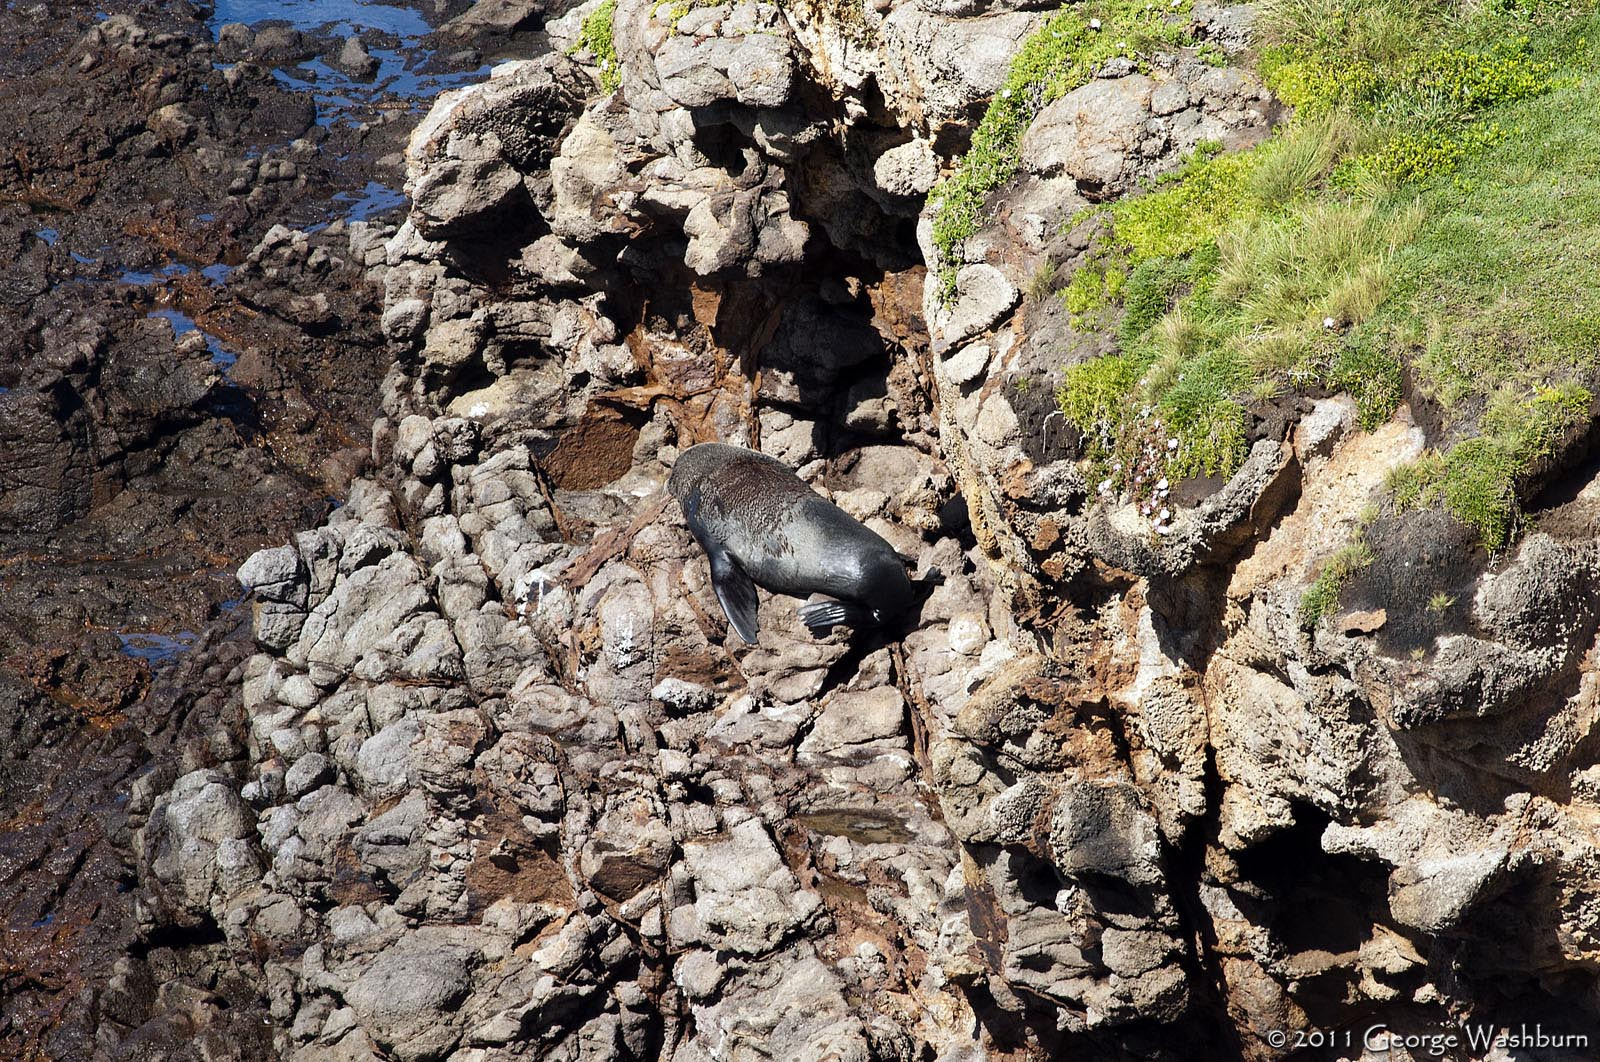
[1058,0,1600,549]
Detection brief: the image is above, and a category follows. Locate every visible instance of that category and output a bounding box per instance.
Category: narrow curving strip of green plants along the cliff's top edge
[930,0,1189,297]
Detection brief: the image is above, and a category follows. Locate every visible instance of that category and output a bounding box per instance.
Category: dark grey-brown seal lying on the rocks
[667,443,914,645]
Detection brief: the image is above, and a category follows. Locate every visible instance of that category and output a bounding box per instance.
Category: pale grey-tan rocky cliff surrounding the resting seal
[9,0,1600,1062]
